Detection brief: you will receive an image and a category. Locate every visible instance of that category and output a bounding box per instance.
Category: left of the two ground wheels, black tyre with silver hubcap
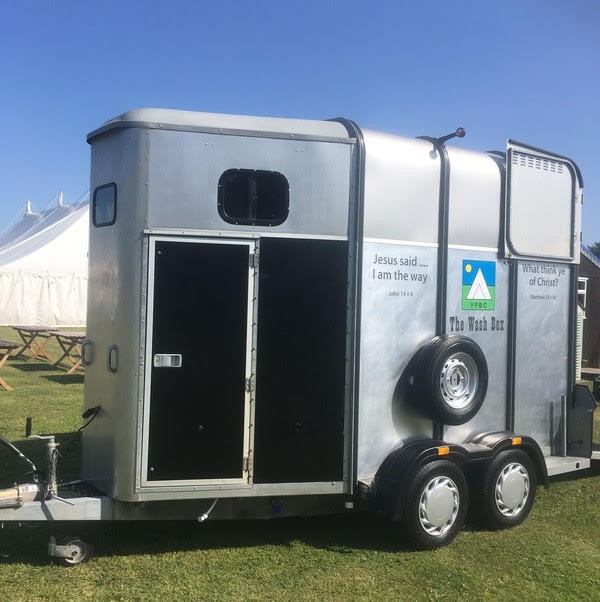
[402,460,468,550]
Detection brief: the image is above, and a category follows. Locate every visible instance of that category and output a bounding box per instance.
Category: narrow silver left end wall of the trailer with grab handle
[82,124,147,497]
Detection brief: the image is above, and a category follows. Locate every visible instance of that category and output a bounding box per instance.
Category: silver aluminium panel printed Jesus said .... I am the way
[356,131,440,483]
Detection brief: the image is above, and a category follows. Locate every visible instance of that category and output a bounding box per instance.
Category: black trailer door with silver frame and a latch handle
[143,238,254,484]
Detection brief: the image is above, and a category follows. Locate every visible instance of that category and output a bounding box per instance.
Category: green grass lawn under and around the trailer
[0,329,600,601]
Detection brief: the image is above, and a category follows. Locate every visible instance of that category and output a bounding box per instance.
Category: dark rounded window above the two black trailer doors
[218,169,290,226]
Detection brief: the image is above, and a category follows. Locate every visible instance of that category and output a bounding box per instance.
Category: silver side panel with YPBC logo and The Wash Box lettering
[444,147,512,443]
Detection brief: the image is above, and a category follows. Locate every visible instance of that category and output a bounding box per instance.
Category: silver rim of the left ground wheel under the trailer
[419,476,460,536]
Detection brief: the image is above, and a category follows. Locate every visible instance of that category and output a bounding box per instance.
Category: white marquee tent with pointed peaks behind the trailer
[0,193,89,327]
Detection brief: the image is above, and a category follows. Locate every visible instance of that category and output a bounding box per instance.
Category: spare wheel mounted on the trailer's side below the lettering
[414,335,488,425]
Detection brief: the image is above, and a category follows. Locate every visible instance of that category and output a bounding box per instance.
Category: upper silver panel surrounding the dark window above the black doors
[145,130,351,238]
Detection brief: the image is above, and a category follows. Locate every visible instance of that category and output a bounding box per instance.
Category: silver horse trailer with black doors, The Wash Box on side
[0,109,595,562]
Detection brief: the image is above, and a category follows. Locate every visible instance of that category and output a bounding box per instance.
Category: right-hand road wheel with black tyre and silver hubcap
[480,449,537,529]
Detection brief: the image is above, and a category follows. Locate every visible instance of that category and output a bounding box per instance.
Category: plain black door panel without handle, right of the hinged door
[253,237,348,484]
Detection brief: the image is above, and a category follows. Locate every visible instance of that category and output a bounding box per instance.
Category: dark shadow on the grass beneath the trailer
[0,513,411,565]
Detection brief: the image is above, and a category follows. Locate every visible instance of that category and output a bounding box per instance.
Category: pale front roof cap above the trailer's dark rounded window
[87,108,351,143]
